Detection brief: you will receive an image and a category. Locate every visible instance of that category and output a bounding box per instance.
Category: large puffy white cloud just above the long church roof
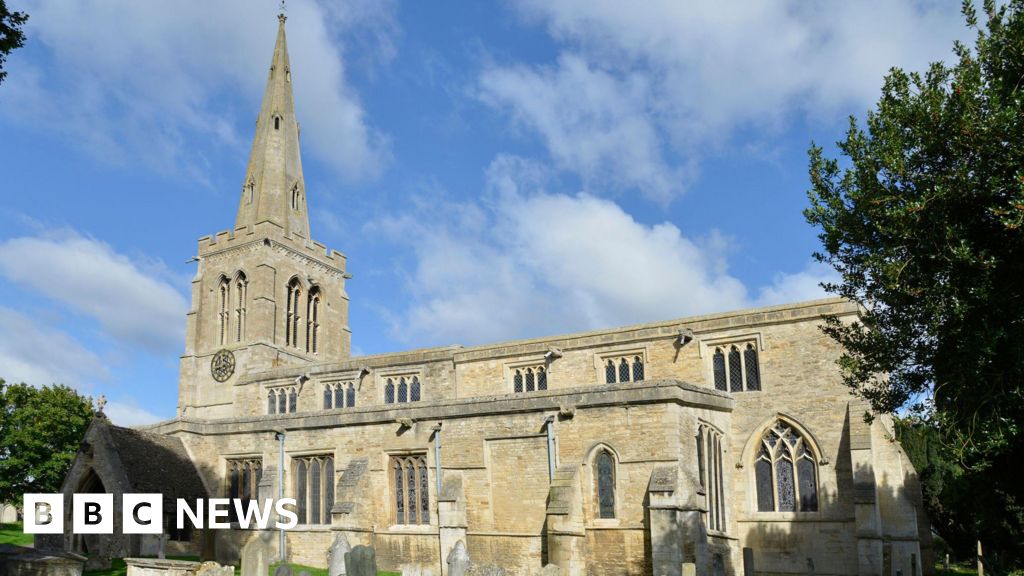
[368,153,746,344]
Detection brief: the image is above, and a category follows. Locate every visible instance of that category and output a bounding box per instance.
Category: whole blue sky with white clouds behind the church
[0,0,971,425]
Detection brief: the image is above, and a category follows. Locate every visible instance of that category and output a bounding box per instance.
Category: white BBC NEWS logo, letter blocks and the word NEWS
[23,494,299,534]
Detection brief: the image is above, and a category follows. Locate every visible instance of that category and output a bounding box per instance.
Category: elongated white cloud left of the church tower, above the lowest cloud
[0,233,188,354]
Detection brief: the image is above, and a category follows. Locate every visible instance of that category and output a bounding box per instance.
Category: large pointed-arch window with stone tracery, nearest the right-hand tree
[754,420,818,512]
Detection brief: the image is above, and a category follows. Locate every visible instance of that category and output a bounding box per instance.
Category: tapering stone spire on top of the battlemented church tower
[234,13,309,238]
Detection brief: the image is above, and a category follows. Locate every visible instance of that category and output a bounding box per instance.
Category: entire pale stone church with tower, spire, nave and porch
[51,16,932,576]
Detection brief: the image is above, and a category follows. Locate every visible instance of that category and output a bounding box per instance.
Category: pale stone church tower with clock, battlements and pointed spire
[178,14,351,418]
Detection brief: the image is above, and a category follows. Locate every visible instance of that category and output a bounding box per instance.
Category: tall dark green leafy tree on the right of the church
[805,0,1024,552]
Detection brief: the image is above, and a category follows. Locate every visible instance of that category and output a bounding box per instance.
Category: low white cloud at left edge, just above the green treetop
[0,306,109,387]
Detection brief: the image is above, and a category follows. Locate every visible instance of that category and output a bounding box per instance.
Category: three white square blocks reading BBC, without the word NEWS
[24,494,164,534]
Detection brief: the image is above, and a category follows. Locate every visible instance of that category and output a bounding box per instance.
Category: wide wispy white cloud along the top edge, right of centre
[479,0,968,200]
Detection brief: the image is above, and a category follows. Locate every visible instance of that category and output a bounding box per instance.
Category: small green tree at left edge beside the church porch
[0,379,93,502]
